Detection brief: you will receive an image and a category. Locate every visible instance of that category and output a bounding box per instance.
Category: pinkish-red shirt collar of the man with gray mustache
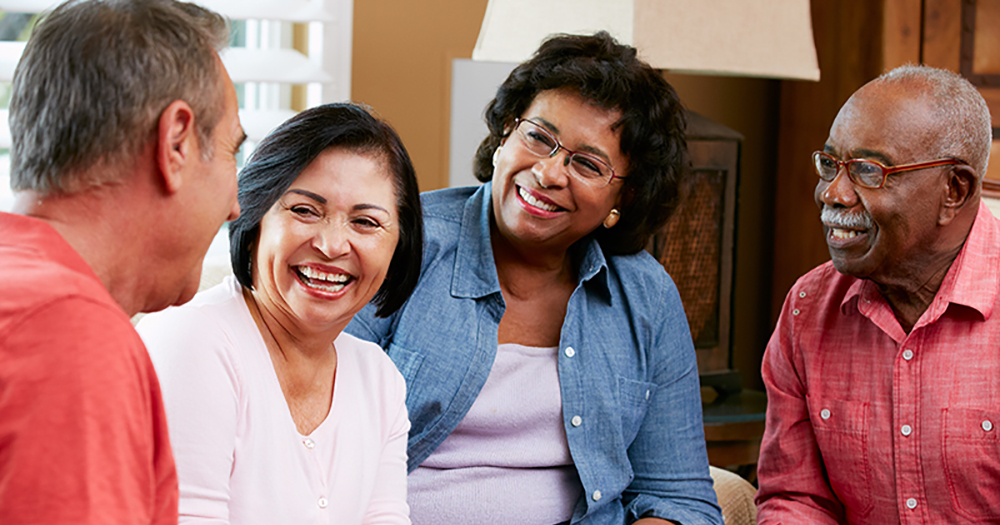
[840,202,1000,322]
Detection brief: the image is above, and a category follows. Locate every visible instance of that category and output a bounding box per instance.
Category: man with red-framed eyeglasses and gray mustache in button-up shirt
[757,66,1000,525]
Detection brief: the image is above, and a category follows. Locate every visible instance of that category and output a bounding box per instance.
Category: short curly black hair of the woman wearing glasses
[473,31,687,255]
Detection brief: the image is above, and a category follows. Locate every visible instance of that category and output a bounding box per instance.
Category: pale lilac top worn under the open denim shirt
[409,344,582,525]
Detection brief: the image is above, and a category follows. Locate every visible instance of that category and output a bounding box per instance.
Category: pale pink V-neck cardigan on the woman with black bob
[138,278,410,525]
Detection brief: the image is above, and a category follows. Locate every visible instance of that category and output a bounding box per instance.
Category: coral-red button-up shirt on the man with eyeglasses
[757,205,1000,525]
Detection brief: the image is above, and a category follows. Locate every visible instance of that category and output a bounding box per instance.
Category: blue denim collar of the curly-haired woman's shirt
[451,182,611,304]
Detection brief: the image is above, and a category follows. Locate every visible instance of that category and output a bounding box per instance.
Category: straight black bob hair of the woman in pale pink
[229,104,424,317]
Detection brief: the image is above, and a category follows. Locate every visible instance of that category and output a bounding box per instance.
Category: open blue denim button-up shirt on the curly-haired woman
[347,183,722,525]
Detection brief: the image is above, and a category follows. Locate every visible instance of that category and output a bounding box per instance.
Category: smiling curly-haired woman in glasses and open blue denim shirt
[347,32,722,525]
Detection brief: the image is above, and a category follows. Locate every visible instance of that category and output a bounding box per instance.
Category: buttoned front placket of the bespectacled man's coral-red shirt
[892,329,926,523]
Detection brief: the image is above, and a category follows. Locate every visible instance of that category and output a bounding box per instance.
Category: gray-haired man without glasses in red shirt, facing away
[0,0,245,525]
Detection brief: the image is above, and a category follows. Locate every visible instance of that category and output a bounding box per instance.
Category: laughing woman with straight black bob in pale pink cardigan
[138,104,423,525]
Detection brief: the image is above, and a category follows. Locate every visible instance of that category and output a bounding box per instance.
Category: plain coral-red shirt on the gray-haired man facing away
[0,213,177,525]
